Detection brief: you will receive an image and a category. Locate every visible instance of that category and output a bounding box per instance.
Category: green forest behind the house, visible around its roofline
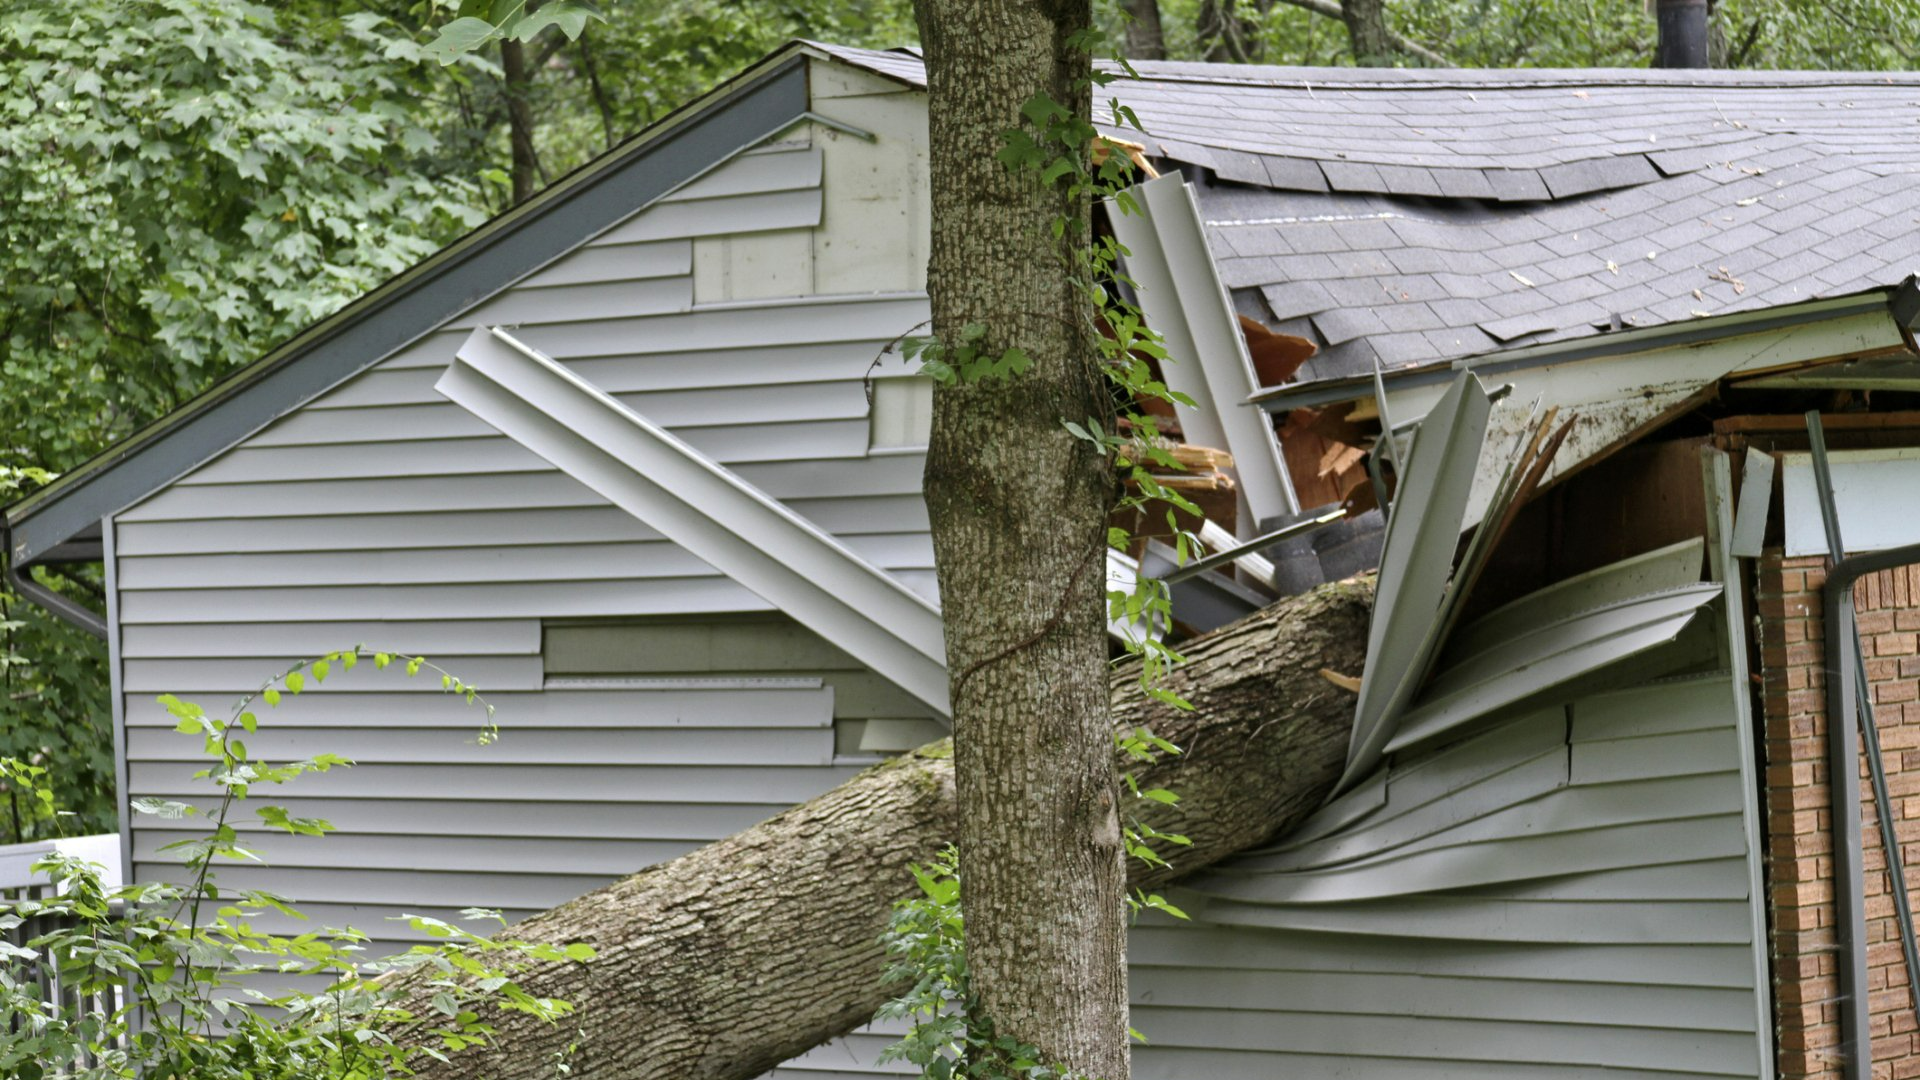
[0,0,1920,844]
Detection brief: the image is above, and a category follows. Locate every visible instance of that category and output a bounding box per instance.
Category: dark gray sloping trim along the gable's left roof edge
[4,46,808,567]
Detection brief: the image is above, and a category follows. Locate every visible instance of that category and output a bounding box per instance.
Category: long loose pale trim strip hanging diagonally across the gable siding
[434,327,952,717]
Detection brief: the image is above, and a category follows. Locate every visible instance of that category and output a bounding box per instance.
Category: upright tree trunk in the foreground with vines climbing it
[914,0,1127,1080]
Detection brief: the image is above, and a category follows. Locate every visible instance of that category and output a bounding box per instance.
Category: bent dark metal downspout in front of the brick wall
[1807,409,1920,1080]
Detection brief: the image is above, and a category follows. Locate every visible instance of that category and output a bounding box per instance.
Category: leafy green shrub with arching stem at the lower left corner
[0,648,576,1080]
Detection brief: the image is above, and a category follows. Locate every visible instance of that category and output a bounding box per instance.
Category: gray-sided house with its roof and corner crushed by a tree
[6,44,1920,1080]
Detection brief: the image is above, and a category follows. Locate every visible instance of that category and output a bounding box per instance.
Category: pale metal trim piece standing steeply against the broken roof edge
[1108,173,1300,527]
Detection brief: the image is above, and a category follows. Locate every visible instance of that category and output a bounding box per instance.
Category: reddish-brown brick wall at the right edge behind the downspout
[1755,550,1920,1080]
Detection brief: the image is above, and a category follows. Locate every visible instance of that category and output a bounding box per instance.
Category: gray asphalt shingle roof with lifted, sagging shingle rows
[814,48,1920,380]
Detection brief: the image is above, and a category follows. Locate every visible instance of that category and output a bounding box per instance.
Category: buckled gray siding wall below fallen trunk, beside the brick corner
[1133,664,1766,1078]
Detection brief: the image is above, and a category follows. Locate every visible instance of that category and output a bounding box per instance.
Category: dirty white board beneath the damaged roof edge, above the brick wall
[1386,309,1905,526]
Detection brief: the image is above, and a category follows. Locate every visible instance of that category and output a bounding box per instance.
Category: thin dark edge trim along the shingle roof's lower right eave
[1246,279,1920,413]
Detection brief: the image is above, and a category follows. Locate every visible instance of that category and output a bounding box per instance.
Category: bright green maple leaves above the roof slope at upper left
[0,0,480,469]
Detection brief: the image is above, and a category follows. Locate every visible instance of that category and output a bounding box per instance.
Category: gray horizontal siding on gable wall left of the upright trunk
[111,125,933,947]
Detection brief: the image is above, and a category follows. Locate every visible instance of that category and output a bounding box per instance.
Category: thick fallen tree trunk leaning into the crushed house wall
[397,582,1371,1080]
